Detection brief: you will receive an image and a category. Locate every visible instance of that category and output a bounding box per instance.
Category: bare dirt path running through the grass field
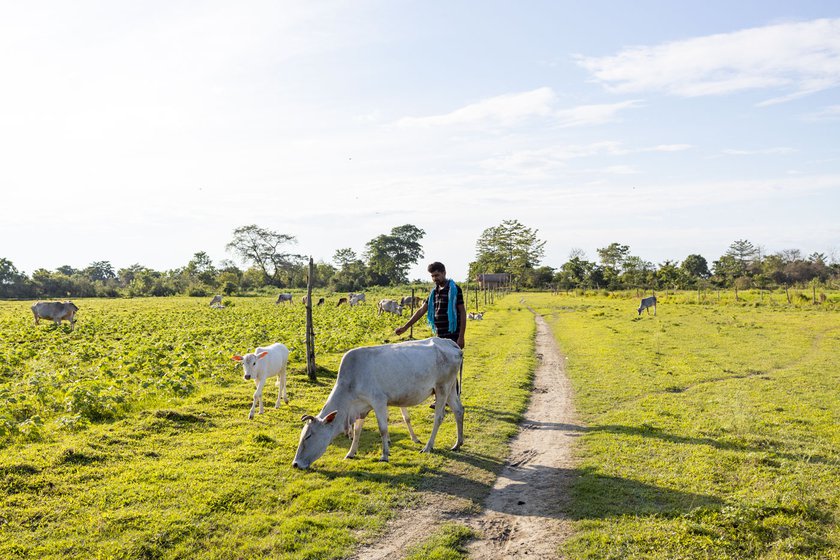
[354,315,580,560]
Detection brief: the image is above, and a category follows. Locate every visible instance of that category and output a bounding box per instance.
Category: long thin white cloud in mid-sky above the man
[397,87,640,128]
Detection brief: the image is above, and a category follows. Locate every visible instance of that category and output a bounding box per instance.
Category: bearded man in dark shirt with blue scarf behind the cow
[394,262,467,348]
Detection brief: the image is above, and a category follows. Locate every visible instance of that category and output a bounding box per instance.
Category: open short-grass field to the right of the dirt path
[524,293,840,559]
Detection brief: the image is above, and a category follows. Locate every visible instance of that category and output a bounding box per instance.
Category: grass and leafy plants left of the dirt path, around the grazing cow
[0,298,534,559]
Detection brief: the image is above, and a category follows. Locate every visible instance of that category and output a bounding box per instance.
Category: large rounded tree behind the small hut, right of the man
[470,220,545,283]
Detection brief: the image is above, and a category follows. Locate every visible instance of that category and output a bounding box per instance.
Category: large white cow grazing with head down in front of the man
[292,338,464,469]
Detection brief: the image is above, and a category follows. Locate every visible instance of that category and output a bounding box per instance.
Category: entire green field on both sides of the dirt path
[0,293,840,559]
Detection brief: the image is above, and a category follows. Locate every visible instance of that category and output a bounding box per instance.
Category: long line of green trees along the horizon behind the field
[0,220,840,299]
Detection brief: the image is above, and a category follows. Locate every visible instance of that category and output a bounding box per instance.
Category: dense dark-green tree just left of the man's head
[364,224,426,285]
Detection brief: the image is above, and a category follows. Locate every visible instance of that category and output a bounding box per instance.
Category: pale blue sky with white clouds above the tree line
[0,1,840,279]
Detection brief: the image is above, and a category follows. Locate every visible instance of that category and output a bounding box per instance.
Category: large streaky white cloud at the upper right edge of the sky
[576,19,840,105]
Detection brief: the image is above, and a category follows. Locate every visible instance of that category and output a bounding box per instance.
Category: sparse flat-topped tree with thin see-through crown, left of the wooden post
[226,224,304,287]
